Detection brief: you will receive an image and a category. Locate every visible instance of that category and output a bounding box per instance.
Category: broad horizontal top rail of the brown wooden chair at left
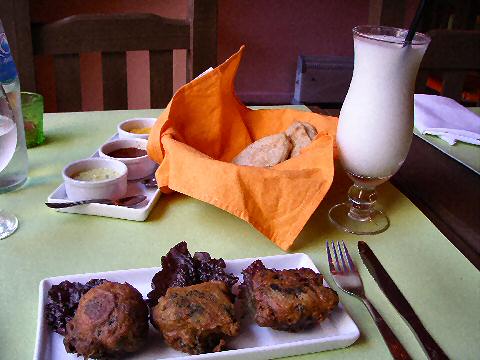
[33,14,190,54]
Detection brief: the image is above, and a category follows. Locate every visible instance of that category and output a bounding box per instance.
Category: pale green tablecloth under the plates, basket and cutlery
[0,110,480,360]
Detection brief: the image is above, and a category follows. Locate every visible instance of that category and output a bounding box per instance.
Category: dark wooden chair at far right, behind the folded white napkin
[416,30,480,102]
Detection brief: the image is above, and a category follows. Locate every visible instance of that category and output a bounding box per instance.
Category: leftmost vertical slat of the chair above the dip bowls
[54,54,82,112]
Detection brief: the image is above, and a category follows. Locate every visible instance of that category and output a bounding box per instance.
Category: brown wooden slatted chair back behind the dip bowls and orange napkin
[32,0,217,111]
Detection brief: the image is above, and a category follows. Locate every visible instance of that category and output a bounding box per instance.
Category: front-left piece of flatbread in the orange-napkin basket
[232,133,292,167]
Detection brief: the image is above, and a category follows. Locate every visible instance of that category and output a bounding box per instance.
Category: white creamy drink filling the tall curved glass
[337,27,428,178]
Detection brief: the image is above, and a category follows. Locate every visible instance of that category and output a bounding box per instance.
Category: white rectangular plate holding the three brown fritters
[33,254,360,360]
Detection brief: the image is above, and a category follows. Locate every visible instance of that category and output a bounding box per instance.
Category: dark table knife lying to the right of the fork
[358,241,448,359]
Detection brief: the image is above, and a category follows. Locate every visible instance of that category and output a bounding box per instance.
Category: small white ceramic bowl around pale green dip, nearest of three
[62,158,127,201]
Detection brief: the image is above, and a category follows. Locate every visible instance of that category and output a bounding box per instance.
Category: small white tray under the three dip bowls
[47,134,161,221]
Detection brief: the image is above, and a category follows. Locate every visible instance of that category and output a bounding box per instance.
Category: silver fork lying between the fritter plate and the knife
[326,240,411,359]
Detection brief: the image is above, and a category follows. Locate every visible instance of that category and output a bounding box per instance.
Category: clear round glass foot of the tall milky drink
[328,202,390,235]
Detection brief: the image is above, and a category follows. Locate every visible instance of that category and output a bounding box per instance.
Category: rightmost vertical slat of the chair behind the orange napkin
[150,50,173,108]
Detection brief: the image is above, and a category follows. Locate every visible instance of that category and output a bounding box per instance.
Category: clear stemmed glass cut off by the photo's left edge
[0,85,18,240]
